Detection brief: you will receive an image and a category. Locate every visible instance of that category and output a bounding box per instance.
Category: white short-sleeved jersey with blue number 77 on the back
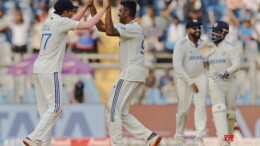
[33,13,79,74]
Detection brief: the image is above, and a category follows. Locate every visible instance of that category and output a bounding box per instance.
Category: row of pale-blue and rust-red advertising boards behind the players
[0,104,260,140]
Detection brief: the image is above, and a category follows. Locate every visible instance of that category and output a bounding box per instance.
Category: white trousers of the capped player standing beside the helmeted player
[176,74,208,137]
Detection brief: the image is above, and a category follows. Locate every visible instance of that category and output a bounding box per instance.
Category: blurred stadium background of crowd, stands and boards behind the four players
[0,0,260,146]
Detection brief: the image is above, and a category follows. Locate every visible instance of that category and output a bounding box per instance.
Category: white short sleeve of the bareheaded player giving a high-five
[115,24,140,38]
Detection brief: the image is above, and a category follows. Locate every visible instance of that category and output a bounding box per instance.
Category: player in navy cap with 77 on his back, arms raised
[23,0,108,146]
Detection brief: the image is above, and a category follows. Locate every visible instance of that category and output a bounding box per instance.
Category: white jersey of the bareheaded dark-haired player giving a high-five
[116,19,147,82]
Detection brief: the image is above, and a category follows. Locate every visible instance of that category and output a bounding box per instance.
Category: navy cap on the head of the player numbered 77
[54,0,78,11]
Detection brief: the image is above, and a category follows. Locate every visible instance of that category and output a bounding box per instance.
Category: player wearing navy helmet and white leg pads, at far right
[208,21,240,146]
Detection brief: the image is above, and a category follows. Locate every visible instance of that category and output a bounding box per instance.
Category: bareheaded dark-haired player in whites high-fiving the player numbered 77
[91,0,162,146]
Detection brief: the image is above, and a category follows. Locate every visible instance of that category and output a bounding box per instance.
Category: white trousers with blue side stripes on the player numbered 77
[28,72,63,146]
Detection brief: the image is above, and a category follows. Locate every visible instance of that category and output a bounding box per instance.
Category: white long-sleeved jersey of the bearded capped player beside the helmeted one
[173,36,204,85]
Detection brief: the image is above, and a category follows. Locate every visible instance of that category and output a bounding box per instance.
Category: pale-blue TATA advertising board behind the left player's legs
[0,104,107,140]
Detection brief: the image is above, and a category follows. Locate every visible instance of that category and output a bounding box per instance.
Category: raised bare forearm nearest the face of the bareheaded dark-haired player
[105,6,120,36]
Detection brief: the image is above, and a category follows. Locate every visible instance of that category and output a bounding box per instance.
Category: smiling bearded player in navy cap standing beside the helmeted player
[173,19,207,145]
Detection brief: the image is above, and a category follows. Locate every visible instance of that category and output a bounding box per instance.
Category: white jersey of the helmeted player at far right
[208,40,240,79]
